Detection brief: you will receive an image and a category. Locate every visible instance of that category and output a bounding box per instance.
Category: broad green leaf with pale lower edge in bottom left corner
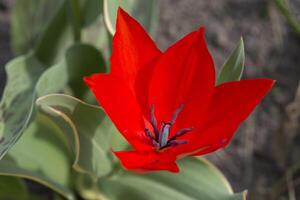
[0,114,74,199]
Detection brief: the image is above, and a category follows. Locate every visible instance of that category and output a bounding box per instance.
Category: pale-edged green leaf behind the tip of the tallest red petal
[103,0,159,35]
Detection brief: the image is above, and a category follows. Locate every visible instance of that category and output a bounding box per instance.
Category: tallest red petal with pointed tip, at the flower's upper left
[111,8,160,87]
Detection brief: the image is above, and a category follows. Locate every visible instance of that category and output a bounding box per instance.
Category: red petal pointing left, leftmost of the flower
[84,74,145,149]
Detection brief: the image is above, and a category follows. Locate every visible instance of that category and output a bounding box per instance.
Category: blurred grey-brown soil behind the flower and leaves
[0,0,300,200]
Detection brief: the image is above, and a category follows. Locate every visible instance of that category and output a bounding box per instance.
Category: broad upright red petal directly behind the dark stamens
[149,28,215,130]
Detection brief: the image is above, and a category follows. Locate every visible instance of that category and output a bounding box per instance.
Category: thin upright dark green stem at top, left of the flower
[69,0,81,42]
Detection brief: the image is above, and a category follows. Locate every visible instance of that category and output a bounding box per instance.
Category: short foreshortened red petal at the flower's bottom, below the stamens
[114,151,179,173]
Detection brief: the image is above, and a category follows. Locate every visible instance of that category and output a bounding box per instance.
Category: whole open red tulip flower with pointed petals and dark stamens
[84,9,274,172]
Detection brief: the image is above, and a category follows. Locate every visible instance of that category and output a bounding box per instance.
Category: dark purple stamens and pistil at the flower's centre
[144,104,192,150]
